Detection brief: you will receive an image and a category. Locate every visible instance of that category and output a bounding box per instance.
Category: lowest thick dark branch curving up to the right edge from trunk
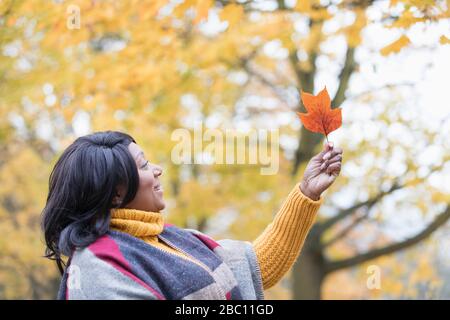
[325,205,450,274]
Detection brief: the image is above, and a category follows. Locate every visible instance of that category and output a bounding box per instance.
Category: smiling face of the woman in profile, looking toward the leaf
[121,142,166,212]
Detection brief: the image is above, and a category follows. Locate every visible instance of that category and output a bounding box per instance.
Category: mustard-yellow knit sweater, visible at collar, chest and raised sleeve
[111,184,323,290]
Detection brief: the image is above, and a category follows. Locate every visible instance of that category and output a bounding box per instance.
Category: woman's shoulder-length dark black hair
[42,131,139,274]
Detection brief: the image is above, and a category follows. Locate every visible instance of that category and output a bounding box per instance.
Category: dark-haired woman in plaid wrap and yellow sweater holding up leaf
[42,131,342,300]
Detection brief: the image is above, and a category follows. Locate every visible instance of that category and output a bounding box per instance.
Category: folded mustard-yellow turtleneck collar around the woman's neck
[110,209,164,238]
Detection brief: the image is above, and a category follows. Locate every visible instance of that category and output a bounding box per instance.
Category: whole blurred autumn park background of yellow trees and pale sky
[0,0,450,299]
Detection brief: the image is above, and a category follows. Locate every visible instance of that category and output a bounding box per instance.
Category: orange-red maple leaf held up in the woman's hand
[297,87,342,141]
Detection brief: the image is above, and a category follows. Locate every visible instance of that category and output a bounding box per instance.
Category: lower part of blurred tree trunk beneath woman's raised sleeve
[292,227,325,300]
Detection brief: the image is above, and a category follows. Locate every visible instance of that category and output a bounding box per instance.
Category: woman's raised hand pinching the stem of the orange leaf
[300,142,342,200]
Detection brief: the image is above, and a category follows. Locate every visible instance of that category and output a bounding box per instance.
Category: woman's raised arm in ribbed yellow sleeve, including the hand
[252,143,342,290]
